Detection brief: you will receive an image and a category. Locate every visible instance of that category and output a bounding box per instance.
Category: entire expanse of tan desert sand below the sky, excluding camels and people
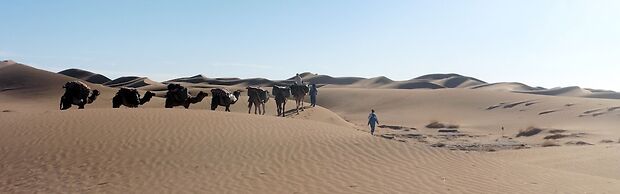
[0,61,620,193]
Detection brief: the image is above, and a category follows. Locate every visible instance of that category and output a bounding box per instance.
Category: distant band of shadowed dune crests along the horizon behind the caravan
[59,66,620,99]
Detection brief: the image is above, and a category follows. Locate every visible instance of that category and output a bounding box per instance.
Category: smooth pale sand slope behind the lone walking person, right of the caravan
[319,88,620,146]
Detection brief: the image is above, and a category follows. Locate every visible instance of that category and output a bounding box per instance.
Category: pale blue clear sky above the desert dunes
[0,0,620,91]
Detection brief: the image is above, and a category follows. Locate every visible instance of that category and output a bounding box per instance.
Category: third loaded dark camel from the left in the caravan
[165,84,209,109]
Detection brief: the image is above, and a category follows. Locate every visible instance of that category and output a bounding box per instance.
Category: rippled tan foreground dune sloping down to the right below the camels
[0,109,620,193]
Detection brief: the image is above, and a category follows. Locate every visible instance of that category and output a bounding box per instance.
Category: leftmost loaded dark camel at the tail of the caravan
[60,81,100,110]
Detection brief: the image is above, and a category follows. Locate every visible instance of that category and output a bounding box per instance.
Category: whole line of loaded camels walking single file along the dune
[60,74,309,117]
